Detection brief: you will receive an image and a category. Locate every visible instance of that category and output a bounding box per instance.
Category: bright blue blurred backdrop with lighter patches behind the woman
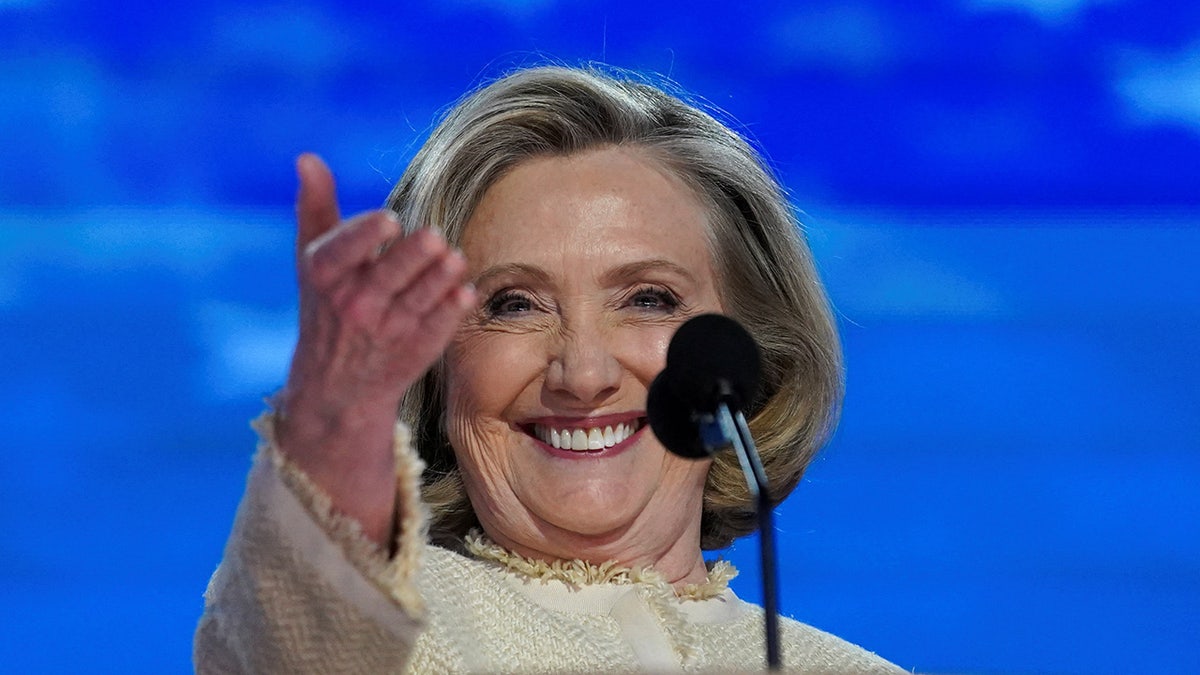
[0,0,1200,673]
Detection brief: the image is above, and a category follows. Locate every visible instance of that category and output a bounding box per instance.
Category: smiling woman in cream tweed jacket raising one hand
[196,67,896,673]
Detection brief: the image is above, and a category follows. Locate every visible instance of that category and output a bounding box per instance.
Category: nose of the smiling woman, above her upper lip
[546,327,622,406]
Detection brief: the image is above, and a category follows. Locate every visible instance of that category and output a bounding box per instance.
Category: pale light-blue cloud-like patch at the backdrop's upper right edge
[1114,40,1200,133]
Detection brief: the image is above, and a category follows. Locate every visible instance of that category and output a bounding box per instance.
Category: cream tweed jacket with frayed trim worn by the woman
[193,416,904,674]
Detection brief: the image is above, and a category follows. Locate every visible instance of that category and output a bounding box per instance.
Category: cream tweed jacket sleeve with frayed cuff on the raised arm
[193,413,427,674]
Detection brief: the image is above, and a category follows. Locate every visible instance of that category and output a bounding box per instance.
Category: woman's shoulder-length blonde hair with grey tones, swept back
[388,66,842,549]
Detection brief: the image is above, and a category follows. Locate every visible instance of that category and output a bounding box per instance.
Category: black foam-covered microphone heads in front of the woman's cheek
[646,313,761,459]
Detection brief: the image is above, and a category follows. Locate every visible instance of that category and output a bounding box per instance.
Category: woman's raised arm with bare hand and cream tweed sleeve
[194,155,474,673]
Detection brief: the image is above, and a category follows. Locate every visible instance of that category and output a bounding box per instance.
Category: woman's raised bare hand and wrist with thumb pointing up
[276,155,475,544]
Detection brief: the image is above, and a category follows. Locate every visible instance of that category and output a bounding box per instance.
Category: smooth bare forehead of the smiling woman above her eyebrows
[461,147,710,270]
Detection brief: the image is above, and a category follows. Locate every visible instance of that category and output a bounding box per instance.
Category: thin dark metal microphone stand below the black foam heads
[698,398,781,671]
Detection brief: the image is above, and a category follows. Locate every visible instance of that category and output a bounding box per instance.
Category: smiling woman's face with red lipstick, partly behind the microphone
[445,148,722,562]
